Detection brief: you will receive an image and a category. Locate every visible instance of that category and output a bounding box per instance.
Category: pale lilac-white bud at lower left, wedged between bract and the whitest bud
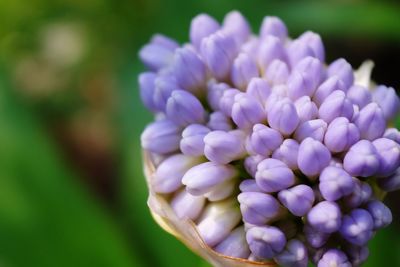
[171,189,206,221]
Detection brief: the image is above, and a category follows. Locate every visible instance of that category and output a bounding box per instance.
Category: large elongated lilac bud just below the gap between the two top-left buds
[201,32,237,81]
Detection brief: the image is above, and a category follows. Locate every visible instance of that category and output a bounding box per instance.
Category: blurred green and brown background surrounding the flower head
[0,0,400,267]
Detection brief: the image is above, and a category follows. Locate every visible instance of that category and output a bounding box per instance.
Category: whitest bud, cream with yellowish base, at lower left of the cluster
[197,198,241,247]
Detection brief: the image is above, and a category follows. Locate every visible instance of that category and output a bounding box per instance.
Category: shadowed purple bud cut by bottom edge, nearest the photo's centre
[275,239,308,267]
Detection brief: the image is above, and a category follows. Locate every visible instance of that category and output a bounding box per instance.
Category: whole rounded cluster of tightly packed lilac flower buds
[139,11,400,267]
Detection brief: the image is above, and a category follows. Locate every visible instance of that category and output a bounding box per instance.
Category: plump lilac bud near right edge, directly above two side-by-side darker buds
[355,103,386,141]
